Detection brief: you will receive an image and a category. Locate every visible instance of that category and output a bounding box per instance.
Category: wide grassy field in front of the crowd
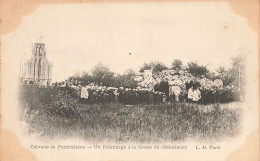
[19,86,241,143]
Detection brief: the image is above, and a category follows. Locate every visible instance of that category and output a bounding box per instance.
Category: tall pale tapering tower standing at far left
[20,43,52,86]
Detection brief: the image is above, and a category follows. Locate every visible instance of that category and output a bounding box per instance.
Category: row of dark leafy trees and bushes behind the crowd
[68,55,245,93]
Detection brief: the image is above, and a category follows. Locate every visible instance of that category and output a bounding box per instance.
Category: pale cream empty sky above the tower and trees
[1,2,257,80]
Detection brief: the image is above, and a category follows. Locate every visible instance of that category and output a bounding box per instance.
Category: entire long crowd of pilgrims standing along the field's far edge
[21,75,241,105]
